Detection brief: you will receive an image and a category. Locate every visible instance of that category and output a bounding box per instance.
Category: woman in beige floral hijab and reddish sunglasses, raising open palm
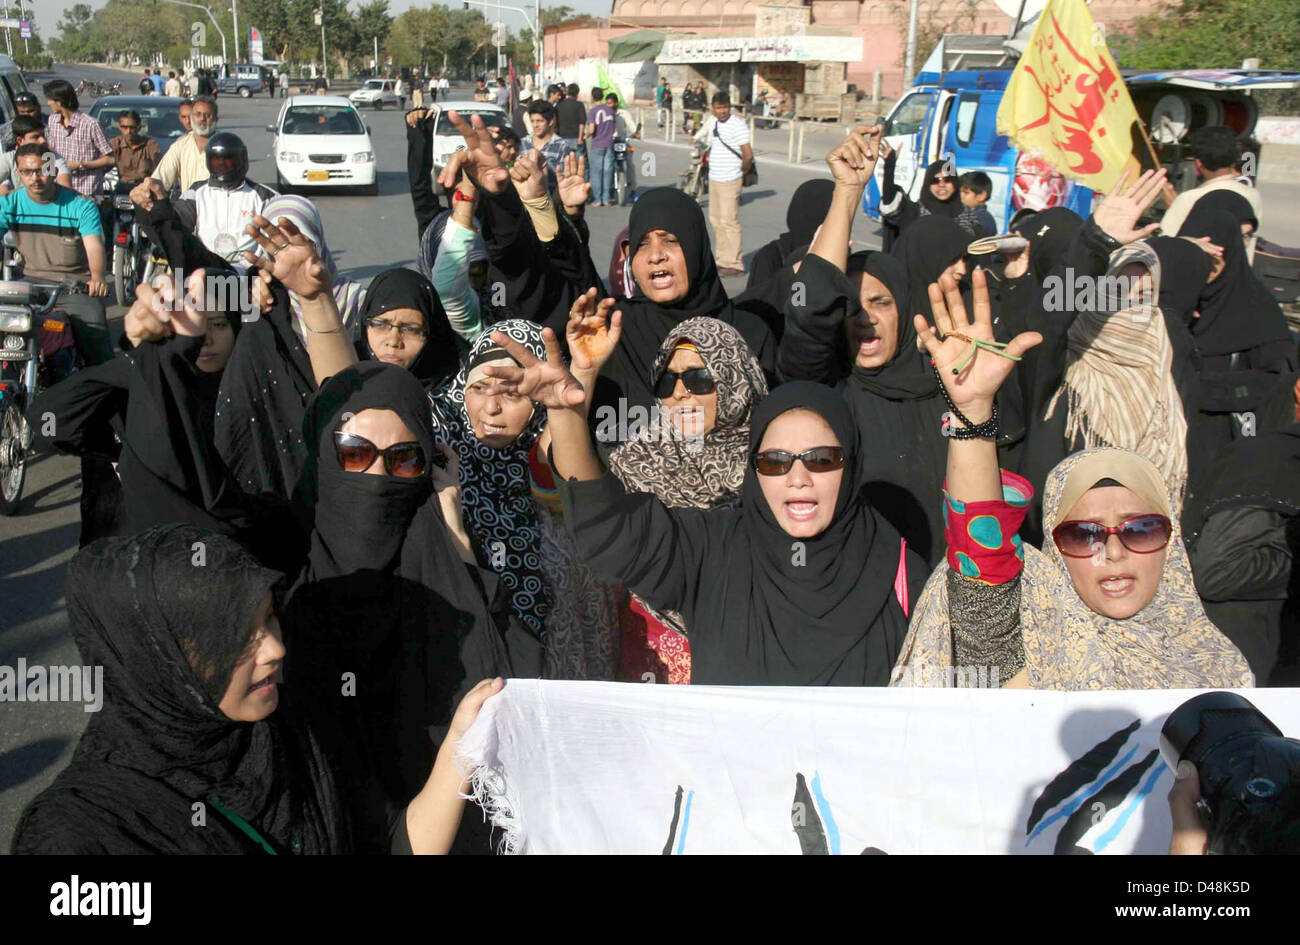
[893,270,1253,690]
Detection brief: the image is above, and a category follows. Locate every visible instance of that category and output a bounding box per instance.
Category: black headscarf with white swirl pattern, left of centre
[429,318,551,637]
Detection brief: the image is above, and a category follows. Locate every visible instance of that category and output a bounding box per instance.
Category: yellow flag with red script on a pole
[997,0,1145,191]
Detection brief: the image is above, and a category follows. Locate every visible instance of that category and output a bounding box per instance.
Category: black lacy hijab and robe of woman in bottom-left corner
[14,525,350,853]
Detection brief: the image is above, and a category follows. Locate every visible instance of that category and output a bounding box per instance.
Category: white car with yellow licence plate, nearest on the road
[267,95,380,196]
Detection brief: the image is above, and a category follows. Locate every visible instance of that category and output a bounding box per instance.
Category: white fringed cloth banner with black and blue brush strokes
[462,680,1300,855]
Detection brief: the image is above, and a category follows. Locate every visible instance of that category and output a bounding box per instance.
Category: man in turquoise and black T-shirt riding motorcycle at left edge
[0,144,113,364]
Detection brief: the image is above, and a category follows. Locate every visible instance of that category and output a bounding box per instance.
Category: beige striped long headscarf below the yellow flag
[1047,242,1187,517]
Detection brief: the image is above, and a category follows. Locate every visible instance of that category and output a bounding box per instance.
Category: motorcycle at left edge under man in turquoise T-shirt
[0,276,77,515]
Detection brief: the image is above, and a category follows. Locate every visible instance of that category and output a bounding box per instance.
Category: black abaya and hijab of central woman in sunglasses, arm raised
[558,381,928,686]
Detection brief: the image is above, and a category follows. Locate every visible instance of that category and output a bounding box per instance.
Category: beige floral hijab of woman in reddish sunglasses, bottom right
[891,448,1255,690]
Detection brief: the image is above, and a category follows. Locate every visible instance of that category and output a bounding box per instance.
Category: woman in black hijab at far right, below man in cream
[1178,205,1296,373]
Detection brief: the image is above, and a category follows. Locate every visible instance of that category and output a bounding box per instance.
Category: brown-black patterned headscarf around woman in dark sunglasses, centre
[610,317,767,508]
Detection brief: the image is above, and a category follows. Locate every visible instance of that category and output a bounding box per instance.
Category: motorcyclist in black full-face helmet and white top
[133,131,277,273]
